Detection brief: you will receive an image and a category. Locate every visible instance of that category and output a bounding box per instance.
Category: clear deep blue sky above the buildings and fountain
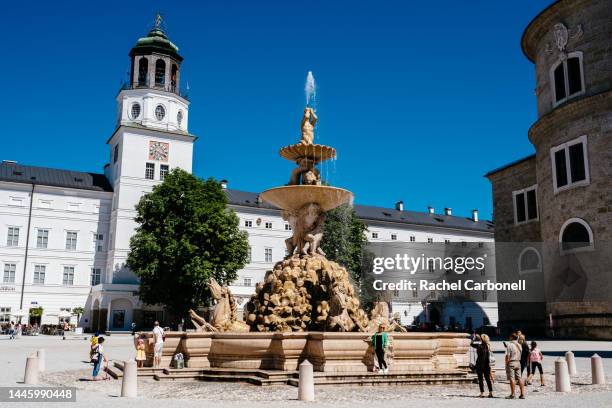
[0,0,550,219]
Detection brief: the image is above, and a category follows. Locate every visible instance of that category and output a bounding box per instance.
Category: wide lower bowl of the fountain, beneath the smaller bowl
[261,185,353,211]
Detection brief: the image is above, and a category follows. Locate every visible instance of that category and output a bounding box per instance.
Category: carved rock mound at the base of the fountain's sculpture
[246,255,368,332]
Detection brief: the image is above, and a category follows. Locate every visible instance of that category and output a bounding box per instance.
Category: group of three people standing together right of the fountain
[471,331,545,399]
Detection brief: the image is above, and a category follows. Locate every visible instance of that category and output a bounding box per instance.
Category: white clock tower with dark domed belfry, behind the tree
[102,15,196,327]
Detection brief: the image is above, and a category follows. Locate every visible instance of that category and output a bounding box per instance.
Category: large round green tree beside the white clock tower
[127,168,248,316]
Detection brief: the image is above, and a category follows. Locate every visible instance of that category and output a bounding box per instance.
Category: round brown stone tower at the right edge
[521,0,612,338]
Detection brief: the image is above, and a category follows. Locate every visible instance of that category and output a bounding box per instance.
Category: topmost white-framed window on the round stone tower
[550,51,584,106]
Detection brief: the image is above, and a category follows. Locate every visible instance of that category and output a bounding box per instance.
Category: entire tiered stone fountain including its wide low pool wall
[140,78,469,384]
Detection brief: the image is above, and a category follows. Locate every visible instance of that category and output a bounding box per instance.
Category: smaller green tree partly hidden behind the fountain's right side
[321,204,368,287]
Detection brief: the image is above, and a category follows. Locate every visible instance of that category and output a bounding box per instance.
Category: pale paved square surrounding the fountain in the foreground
[0,336,612,408]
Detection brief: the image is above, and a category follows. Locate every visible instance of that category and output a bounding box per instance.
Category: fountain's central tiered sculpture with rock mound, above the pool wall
[245,106,368,332]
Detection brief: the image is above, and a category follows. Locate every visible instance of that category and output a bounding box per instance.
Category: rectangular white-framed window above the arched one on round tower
[550,136,589,193]
